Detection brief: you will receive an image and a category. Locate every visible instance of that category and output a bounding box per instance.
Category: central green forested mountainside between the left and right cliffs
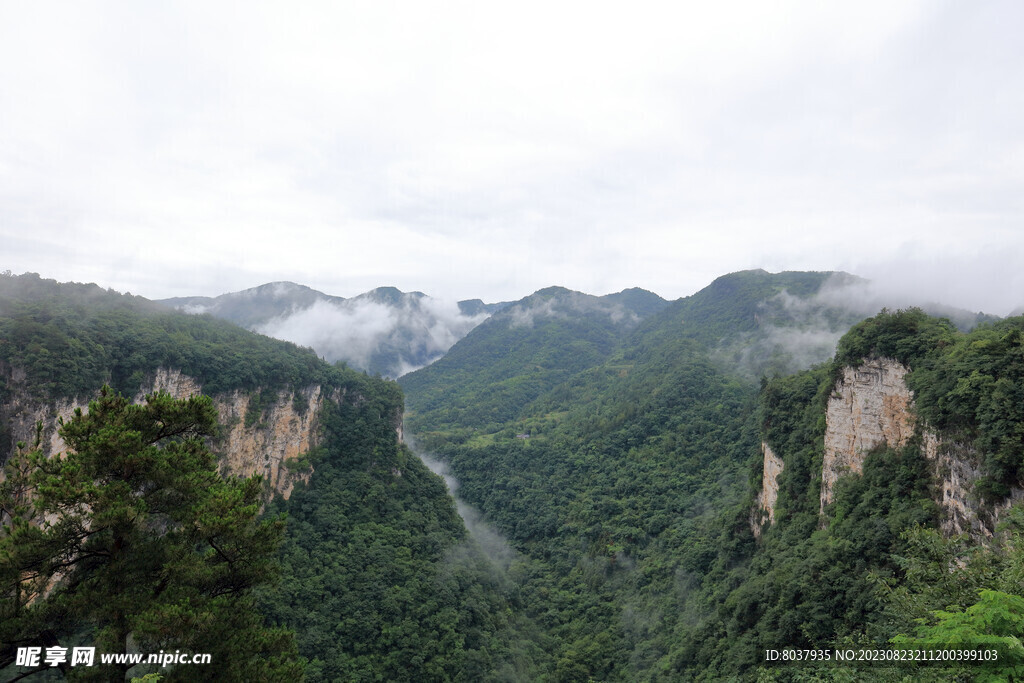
[402,271,856,680]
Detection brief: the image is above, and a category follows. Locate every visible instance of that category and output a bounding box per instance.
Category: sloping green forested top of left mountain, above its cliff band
[0,274,346,400]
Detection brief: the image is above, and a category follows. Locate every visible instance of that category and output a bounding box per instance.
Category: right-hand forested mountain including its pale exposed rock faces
[729,310,1024,680]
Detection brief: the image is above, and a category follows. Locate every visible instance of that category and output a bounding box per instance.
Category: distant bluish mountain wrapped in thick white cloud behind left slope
[158,283,504,377]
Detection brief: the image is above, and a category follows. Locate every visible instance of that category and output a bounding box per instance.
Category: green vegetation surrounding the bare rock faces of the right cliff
[745,309,1024,680]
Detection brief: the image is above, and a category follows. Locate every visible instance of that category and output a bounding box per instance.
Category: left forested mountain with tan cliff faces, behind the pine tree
[0,275,532,681]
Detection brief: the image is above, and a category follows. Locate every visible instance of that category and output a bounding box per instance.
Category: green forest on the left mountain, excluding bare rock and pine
[0,275,536,681]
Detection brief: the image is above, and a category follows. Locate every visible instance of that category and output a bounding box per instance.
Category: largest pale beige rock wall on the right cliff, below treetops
[821,358,914,511]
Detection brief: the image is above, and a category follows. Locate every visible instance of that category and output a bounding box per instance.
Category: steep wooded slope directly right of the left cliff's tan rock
[262,393,540,681]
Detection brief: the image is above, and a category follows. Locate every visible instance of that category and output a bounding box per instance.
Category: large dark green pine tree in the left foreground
[0,388,302,681]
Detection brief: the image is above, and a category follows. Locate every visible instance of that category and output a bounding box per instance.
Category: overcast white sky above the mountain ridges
[0,0,1024,314]
